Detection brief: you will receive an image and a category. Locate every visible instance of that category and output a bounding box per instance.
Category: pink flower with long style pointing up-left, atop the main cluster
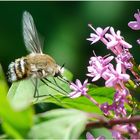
[87,24,109,44]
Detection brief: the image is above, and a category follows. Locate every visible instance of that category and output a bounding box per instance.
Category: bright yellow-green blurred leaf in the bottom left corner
[0,85,33,138]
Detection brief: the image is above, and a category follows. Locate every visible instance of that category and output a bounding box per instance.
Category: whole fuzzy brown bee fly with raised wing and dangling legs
[8,11,68,97]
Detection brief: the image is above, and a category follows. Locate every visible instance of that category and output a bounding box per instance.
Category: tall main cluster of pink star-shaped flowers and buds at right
[87,25,133,123]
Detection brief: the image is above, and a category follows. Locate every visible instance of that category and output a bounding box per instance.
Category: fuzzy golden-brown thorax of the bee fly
[26,54,58,77]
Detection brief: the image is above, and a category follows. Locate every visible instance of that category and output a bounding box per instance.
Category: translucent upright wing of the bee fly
[22,11,42,53]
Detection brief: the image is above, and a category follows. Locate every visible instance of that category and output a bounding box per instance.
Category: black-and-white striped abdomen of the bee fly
[8,58,27,82]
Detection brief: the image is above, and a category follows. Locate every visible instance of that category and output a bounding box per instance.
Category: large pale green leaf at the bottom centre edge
[29,109,87,140]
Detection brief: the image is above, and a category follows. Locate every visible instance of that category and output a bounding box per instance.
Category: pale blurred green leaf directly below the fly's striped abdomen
[7,79,35,110]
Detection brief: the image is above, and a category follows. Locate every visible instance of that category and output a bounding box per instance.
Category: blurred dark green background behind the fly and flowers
[0,1,140,80]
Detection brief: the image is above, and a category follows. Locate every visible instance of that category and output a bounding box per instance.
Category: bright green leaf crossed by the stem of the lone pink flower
[44,86,115,114]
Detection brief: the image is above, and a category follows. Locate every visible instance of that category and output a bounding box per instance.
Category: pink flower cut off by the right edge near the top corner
[128,10,140,30]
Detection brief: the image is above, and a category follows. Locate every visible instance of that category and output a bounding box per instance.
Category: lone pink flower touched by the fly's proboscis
[69,79,88,98]
